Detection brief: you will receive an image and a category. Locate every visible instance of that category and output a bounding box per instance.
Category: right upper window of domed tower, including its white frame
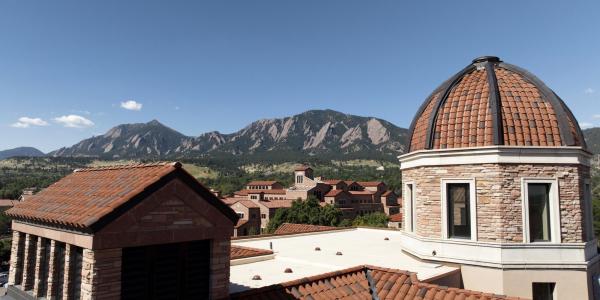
[521,178,560,243]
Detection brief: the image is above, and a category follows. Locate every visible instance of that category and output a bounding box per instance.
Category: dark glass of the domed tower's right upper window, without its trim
[527,183,551,242]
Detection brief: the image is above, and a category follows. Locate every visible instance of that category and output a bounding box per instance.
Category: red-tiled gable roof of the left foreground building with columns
[6,162,238,232]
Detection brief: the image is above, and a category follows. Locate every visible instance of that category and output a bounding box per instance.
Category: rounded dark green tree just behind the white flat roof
[267,196,342,233]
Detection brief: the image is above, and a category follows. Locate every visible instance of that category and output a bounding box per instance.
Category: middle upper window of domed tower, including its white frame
[441,179,477,241]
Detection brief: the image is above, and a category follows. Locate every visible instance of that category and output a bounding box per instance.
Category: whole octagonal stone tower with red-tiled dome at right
[399,57,599,299]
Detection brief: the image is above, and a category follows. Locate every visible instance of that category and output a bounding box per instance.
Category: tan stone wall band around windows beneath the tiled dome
[402,164,590,243]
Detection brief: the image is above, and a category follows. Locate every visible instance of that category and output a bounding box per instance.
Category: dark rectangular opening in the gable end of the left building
[121,241,210,300]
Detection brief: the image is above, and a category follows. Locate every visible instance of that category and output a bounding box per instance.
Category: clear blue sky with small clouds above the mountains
[0,0,600,151]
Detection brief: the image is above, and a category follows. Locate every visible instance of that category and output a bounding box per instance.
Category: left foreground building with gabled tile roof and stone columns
[7,163,238,299]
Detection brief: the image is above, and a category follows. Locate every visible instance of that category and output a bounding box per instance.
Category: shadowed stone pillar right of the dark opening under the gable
[210,239,231,299]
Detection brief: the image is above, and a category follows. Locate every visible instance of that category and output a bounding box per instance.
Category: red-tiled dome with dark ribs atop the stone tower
[409,56,586,152]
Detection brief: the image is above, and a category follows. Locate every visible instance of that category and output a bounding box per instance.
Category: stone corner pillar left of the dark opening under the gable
[81,248,122,299]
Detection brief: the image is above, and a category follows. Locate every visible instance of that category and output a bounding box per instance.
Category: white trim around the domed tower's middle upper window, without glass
[441,178,477,242]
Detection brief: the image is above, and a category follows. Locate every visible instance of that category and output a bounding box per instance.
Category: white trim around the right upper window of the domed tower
[521,178,562,244]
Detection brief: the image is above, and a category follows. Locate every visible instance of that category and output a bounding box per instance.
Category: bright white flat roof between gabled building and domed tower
[229,228,457,293]
